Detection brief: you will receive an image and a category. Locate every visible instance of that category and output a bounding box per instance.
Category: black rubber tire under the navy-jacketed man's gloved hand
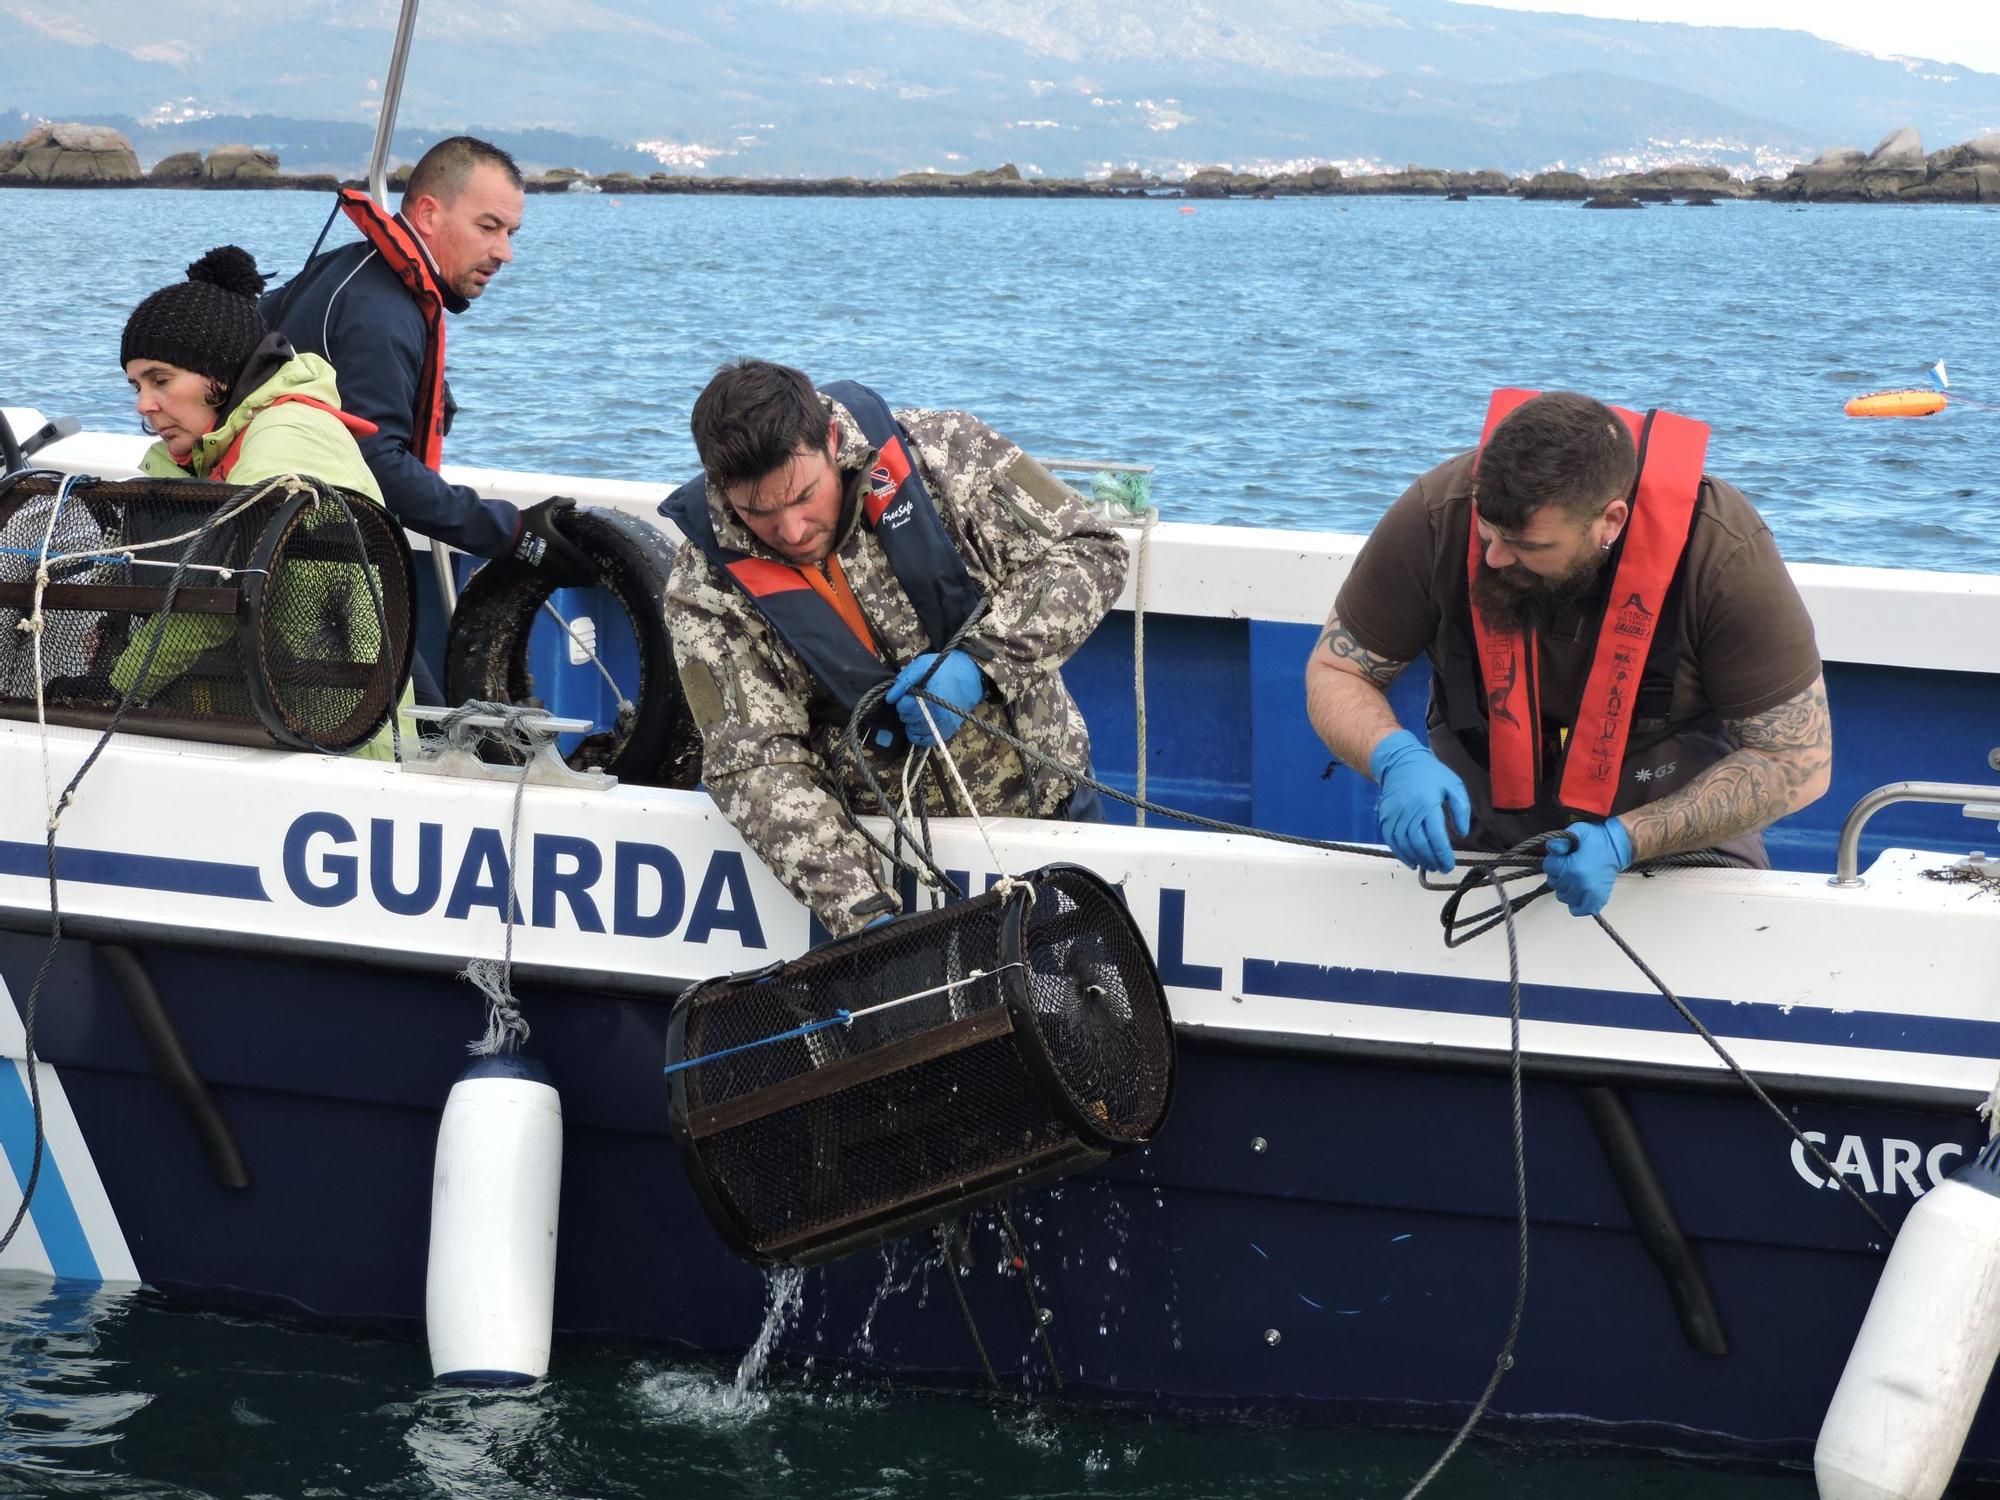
[444,506,702,788]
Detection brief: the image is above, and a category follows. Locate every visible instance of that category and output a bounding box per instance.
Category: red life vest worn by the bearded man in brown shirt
[1466,390,1708,818]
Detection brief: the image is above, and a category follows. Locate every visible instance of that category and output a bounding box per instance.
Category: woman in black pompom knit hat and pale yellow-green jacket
[110,244,410,758]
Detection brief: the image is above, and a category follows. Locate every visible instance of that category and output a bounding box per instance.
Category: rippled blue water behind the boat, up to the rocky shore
[0,192,2000,570]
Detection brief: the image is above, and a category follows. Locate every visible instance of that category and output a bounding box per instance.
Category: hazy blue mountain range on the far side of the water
[0,0,2000,176]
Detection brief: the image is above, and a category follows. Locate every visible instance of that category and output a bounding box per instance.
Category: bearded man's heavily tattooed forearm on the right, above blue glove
[1618,680,1834,860]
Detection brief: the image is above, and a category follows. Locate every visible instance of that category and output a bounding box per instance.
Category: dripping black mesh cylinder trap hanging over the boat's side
[666,866,1174,1266]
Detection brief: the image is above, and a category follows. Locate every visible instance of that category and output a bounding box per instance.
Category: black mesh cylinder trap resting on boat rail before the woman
[0,474,416,752]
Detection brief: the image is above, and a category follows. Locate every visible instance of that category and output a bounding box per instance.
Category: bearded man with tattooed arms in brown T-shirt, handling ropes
[1306,390,1832,916]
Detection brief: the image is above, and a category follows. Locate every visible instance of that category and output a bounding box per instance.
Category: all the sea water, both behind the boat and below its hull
[0,192,2000,1500]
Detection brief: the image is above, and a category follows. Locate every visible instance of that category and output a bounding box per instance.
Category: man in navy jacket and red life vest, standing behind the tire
[264,136,596,698]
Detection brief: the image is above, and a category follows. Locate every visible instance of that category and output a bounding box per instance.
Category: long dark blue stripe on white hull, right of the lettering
[1244,958,2000,1058]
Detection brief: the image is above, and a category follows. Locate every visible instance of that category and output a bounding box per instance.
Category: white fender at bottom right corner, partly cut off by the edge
[1812,1140,2000,1500]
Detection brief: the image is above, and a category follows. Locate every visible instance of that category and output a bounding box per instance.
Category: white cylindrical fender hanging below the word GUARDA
[424,1054,562,1386]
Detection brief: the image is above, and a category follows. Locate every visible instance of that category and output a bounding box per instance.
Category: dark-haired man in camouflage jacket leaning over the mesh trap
[662,360,1128,936]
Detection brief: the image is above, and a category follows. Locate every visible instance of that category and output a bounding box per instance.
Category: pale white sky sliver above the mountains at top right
[1478,0,2000,72]
